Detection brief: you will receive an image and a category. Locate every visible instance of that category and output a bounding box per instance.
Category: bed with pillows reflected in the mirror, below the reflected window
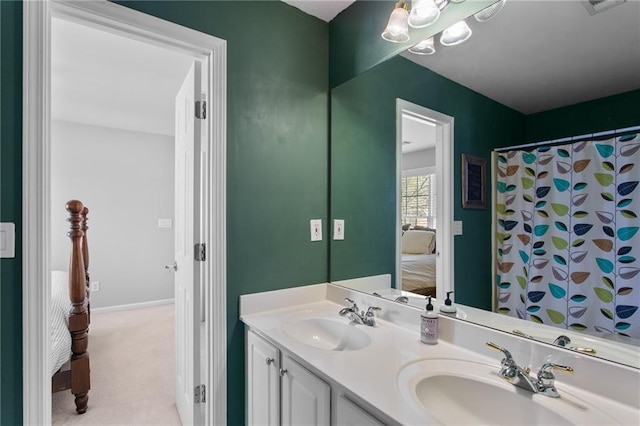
[401,230,436,297]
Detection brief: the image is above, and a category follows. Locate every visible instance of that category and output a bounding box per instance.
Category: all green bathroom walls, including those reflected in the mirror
[0,1,640,425]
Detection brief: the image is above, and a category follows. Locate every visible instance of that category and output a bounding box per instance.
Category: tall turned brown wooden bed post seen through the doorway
[66,200,90,414]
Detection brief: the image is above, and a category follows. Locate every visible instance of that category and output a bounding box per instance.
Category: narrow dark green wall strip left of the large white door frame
[0,1,22,425]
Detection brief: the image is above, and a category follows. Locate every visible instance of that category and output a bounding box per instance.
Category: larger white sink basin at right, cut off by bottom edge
[398,359,616,425]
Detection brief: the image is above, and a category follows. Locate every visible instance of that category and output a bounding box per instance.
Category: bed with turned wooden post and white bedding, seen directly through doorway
[50,200,90,414]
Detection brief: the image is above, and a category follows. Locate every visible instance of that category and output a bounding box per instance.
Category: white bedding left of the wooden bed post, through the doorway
[49,271,71,376]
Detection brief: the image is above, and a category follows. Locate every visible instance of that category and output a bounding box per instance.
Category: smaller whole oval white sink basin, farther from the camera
[282,314,371,351]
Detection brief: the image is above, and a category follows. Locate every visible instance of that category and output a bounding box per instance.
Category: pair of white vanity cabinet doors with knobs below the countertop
[246,330,331,426]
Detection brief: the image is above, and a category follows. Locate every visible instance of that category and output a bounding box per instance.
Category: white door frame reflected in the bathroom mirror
[396,98,455,300]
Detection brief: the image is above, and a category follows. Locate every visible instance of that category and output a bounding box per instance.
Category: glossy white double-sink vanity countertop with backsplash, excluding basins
[240,284,640,425]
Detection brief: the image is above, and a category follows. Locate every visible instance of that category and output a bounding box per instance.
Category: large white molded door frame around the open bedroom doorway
[22,0,227,425]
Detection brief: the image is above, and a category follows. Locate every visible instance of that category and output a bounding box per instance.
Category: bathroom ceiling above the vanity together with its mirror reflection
[287,0,640,114]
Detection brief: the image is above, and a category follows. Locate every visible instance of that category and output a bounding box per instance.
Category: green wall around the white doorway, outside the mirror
[0,1,328,425]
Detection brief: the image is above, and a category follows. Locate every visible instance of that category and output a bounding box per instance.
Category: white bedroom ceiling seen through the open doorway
[51,19,193,135]
